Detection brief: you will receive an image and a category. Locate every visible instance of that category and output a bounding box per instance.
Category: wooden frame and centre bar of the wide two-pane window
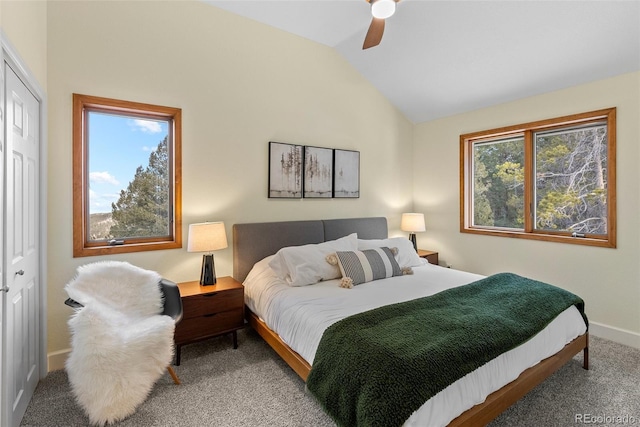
[460,107,617,248]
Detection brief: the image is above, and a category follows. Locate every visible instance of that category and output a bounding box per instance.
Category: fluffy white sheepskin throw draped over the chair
[65,261,175,426]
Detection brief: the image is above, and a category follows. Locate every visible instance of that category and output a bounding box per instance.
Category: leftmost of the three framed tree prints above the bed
[269,142,303,199]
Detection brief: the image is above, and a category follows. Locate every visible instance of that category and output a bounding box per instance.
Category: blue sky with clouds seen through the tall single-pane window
[88,112,168,214]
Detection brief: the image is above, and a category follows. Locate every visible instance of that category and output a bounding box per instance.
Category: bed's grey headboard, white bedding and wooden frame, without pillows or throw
[233,217,589,426]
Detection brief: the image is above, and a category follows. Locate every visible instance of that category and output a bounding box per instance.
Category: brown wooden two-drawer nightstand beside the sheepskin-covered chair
[175,276,244,365]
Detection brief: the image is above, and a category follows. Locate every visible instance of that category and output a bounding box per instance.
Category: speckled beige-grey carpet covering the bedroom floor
[21,329,640,427]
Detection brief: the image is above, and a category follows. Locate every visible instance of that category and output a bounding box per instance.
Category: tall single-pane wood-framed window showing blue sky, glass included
[73,94,182,257]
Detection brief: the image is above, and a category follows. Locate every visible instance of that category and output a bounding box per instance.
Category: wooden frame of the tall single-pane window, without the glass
[73,93,182,257]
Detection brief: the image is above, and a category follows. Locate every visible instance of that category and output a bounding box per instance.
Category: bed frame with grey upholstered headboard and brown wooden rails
[233,218,589,426]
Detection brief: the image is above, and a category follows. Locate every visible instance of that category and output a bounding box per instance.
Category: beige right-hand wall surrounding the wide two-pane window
[413,73,640,347]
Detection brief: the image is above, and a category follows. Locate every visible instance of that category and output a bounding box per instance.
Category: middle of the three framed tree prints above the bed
[303,147,333,198]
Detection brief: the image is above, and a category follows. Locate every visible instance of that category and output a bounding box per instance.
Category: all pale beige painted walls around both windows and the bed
[6,1,640,368]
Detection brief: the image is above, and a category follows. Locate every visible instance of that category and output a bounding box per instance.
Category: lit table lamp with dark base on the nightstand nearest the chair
[187,222,227,285]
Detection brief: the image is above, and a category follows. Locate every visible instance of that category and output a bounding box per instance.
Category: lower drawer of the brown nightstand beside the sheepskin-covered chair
[175,308,244,344]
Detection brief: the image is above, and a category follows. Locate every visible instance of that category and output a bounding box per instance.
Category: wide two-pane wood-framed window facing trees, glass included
[460,108,616,247]
